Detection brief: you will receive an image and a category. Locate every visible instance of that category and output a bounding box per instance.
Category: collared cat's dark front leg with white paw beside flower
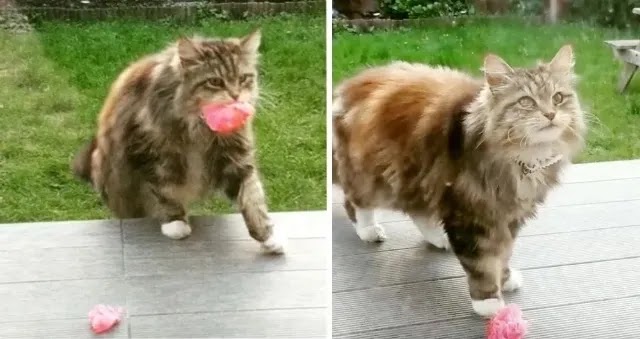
[445,220,512,317]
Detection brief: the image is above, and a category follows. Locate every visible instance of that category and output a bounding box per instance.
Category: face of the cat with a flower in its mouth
[178,31,260,111]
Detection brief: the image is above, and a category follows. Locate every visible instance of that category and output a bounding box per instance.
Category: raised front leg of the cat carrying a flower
[232,169,287,254]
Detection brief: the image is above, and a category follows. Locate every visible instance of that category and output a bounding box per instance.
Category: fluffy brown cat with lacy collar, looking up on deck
[332,45,587,317]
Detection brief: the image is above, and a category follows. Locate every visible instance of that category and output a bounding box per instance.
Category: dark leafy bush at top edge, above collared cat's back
[380,0,472,19]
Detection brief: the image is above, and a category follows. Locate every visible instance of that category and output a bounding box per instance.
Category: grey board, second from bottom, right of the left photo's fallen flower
[127,269,330,315]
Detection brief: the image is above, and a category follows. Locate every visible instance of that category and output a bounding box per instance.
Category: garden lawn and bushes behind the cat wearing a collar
[333,0,640,162]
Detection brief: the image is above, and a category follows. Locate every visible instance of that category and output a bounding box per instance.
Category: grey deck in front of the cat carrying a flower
[0,211,329,338]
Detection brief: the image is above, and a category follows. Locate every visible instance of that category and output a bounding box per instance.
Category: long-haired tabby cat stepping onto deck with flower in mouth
[72,30,285,253]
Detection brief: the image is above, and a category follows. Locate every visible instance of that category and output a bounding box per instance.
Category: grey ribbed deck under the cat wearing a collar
[332,160,640,339]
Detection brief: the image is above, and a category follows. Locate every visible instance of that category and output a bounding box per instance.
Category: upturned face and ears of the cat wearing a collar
[484,46,582,146]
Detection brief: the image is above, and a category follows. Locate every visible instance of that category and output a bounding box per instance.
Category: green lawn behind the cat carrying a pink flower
[0,16,326,222]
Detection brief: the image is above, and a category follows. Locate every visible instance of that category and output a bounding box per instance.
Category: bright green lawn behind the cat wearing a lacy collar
[333,20,640,162]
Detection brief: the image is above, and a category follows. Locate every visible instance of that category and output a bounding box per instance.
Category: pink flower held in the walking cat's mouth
[201,101,254,134]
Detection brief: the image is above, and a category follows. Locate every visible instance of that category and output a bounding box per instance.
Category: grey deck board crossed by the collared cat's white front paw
[333,259,640,335]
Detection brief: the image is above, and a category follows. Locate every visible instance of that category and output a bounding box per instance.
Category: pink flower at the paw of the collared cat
[487,304,529,339]
